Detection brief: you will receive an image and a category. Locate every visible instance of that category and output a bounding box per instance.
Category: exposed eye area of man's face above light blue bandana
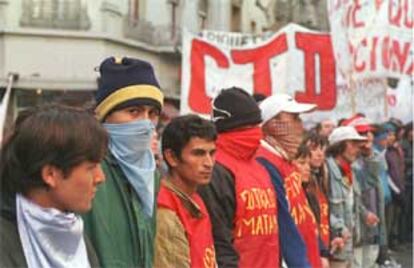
[105,105,160,125]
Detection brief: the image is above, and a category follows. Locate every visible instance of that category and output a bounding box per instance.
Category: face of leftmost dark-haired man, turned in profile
[48,161,105,213]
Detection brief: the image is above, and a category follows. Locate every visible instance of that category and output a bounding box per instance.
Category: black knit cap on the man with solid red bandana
[213,87,262,133]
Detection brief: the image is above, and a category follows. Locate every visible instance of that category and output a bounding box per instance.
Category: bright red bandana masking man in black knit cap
[216,127,262,159]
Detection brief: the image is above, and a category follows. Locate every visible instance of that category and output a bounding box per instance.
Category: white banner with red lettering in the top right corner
[328,0,414,80]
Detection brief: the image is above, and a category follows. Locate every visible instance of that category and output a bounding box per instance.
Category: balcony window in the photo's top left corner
[21,0,90,30]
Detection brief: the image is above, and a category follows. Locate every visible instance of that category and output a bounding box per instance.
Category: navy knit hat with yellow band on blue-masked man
[95,57,164,120]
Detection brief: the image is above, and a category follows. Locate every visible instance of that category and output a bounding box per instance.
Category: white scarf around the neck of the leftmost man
[16,194,90,268]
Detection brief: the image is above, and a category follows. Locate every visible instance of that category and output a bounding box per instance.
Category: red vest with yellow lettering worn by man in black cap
[216,151,279,268]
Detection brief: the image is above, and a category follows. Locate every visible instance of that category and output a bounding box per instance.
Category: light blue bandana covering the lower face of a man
[103,120,156,217]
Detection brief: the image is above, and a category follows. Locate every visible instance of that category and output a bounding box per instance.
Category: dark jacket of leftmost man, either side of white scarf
[0,192,100,267]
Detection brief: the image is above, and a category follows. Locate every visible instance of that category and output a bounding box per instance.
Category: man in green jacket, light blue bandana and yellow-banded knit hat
[80,57,164,267]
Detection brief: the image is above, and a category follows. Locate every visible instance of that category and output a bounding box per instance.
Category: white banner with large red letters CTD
[180,24,412,125]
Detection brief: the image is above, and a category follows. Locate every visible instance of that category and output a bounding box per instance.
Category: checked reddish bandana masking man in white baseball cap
[263,119,303,159]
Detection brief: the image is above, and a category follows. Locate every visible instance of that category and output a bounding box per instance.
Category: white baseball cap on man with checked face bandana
[259,93,316,123]
